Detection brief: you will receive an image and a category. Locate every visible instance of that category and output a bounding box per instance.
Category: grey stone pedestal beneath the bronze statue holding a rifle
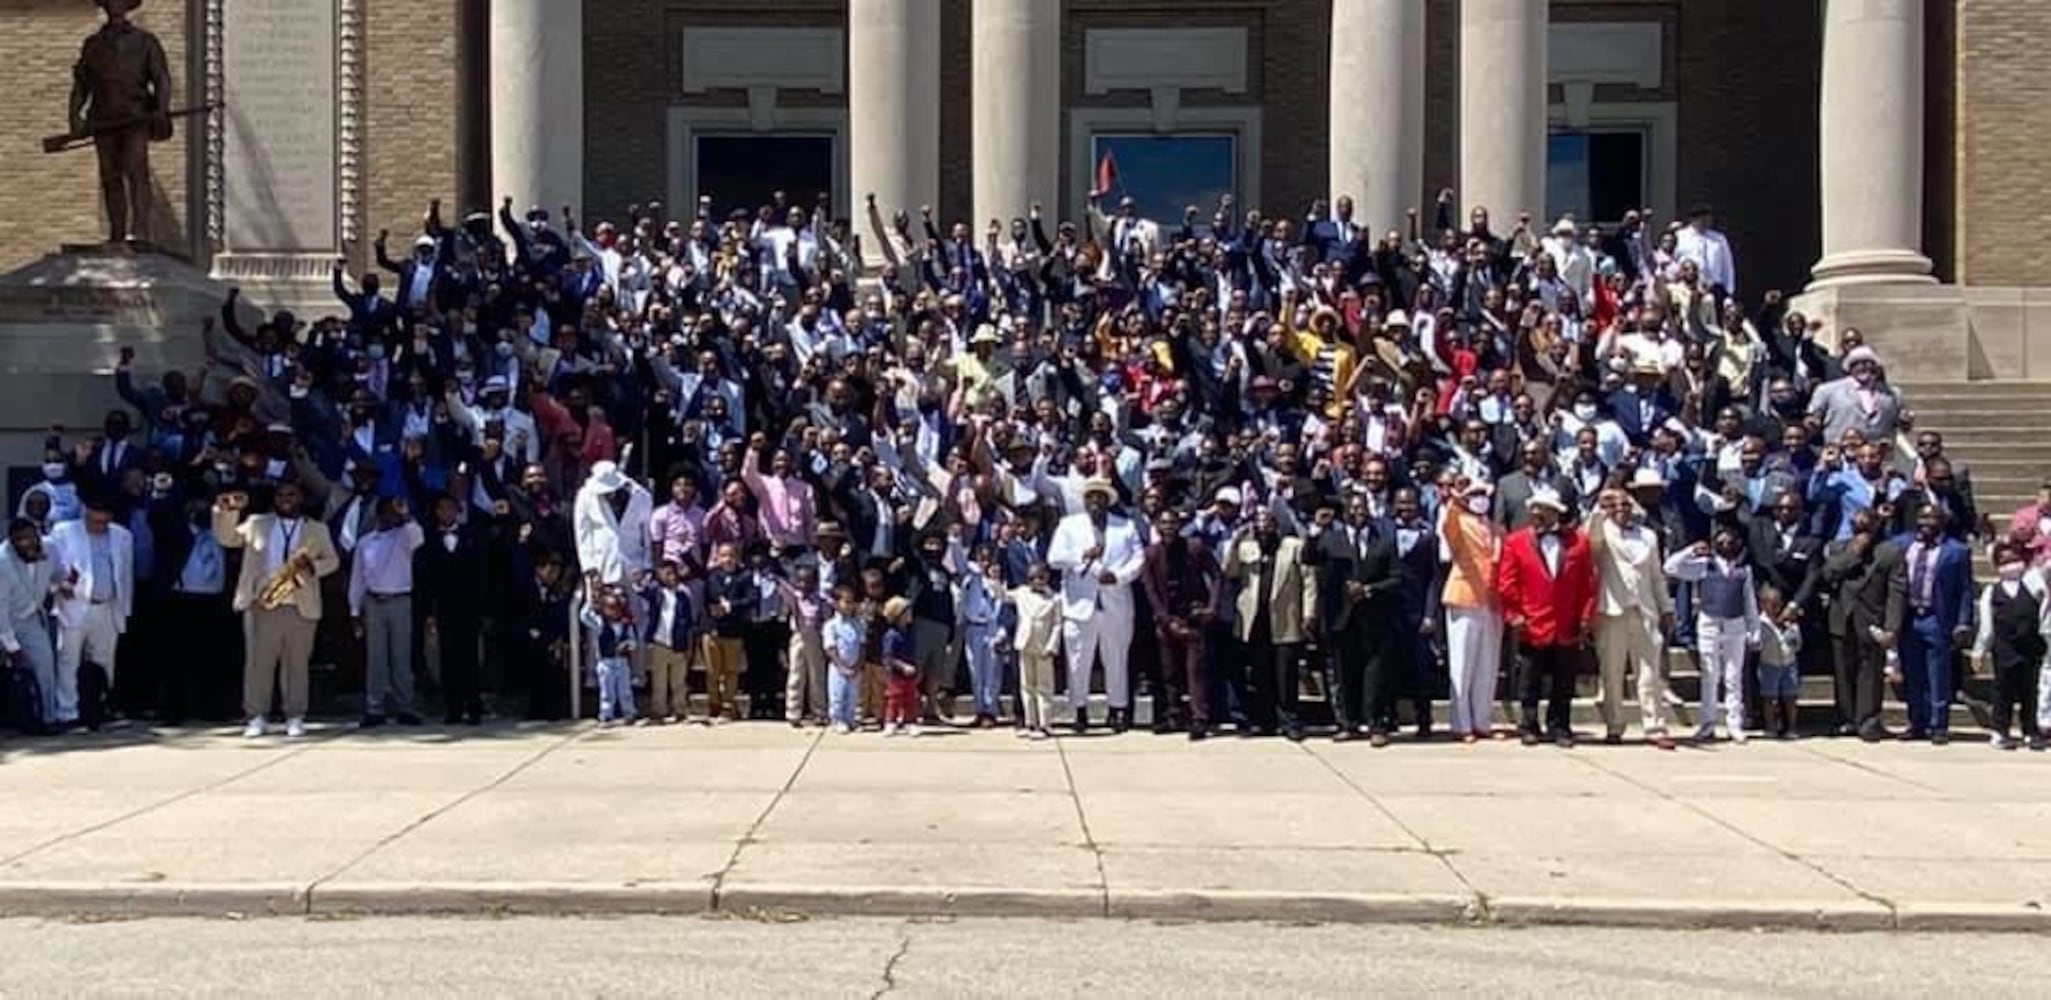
[0,246,234,467]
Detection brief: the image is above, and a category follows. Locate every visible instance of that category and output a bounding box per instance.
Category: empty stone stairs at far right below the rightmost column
[1897,379,2051,540]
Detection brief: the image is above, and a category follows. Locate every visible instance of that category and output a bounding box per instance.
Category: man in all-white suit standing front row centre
[1046,480,1147,732]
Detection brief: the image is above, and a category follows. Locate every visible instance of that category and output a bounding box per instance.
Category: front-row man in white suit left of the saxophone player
[49,492,135,727]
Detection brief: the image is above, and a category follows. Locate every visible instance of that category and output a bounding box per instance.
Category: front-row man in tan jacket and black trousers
[1224,506,1317,740]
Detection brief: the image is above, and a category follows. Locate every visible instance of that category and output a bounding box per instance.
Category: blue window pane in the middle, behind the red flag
[1089,133,1239,225]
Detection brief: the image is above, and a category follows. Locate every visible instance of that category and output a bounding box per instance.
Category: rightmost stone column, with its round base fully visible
[1811,0,1934,287]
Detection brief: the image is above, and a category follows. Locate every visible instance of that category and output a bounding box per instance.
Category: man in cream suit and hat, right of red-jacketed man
[1587,479,1674,750]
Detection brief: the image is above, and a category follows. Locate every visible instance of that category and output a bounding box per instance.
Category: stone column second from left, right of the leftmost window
[847,0,939,222]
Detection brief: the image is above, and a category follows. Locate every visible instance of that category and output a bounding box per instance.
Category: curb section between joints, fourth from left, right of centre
[1108,889,1483,924]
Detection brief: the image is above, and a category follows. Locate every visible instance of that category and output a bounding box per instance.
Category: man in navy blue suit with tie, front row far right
[1895,504,1975,744]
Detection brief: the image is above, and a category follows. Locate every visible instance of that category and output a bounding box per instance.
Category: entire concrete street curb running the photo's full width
[0,879,2051,934]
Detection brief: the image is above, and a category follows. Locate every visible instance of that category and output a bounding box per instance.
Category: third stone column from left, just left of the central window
[970,0,1060,234]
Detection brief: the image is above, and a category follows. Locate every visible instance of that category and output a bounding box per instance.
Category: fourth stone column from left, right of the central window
[1331,0,1423,232]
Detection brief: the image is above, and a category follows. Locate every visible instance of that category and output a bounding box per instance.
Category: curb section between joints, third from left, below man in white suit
[714,883,1103,918]
